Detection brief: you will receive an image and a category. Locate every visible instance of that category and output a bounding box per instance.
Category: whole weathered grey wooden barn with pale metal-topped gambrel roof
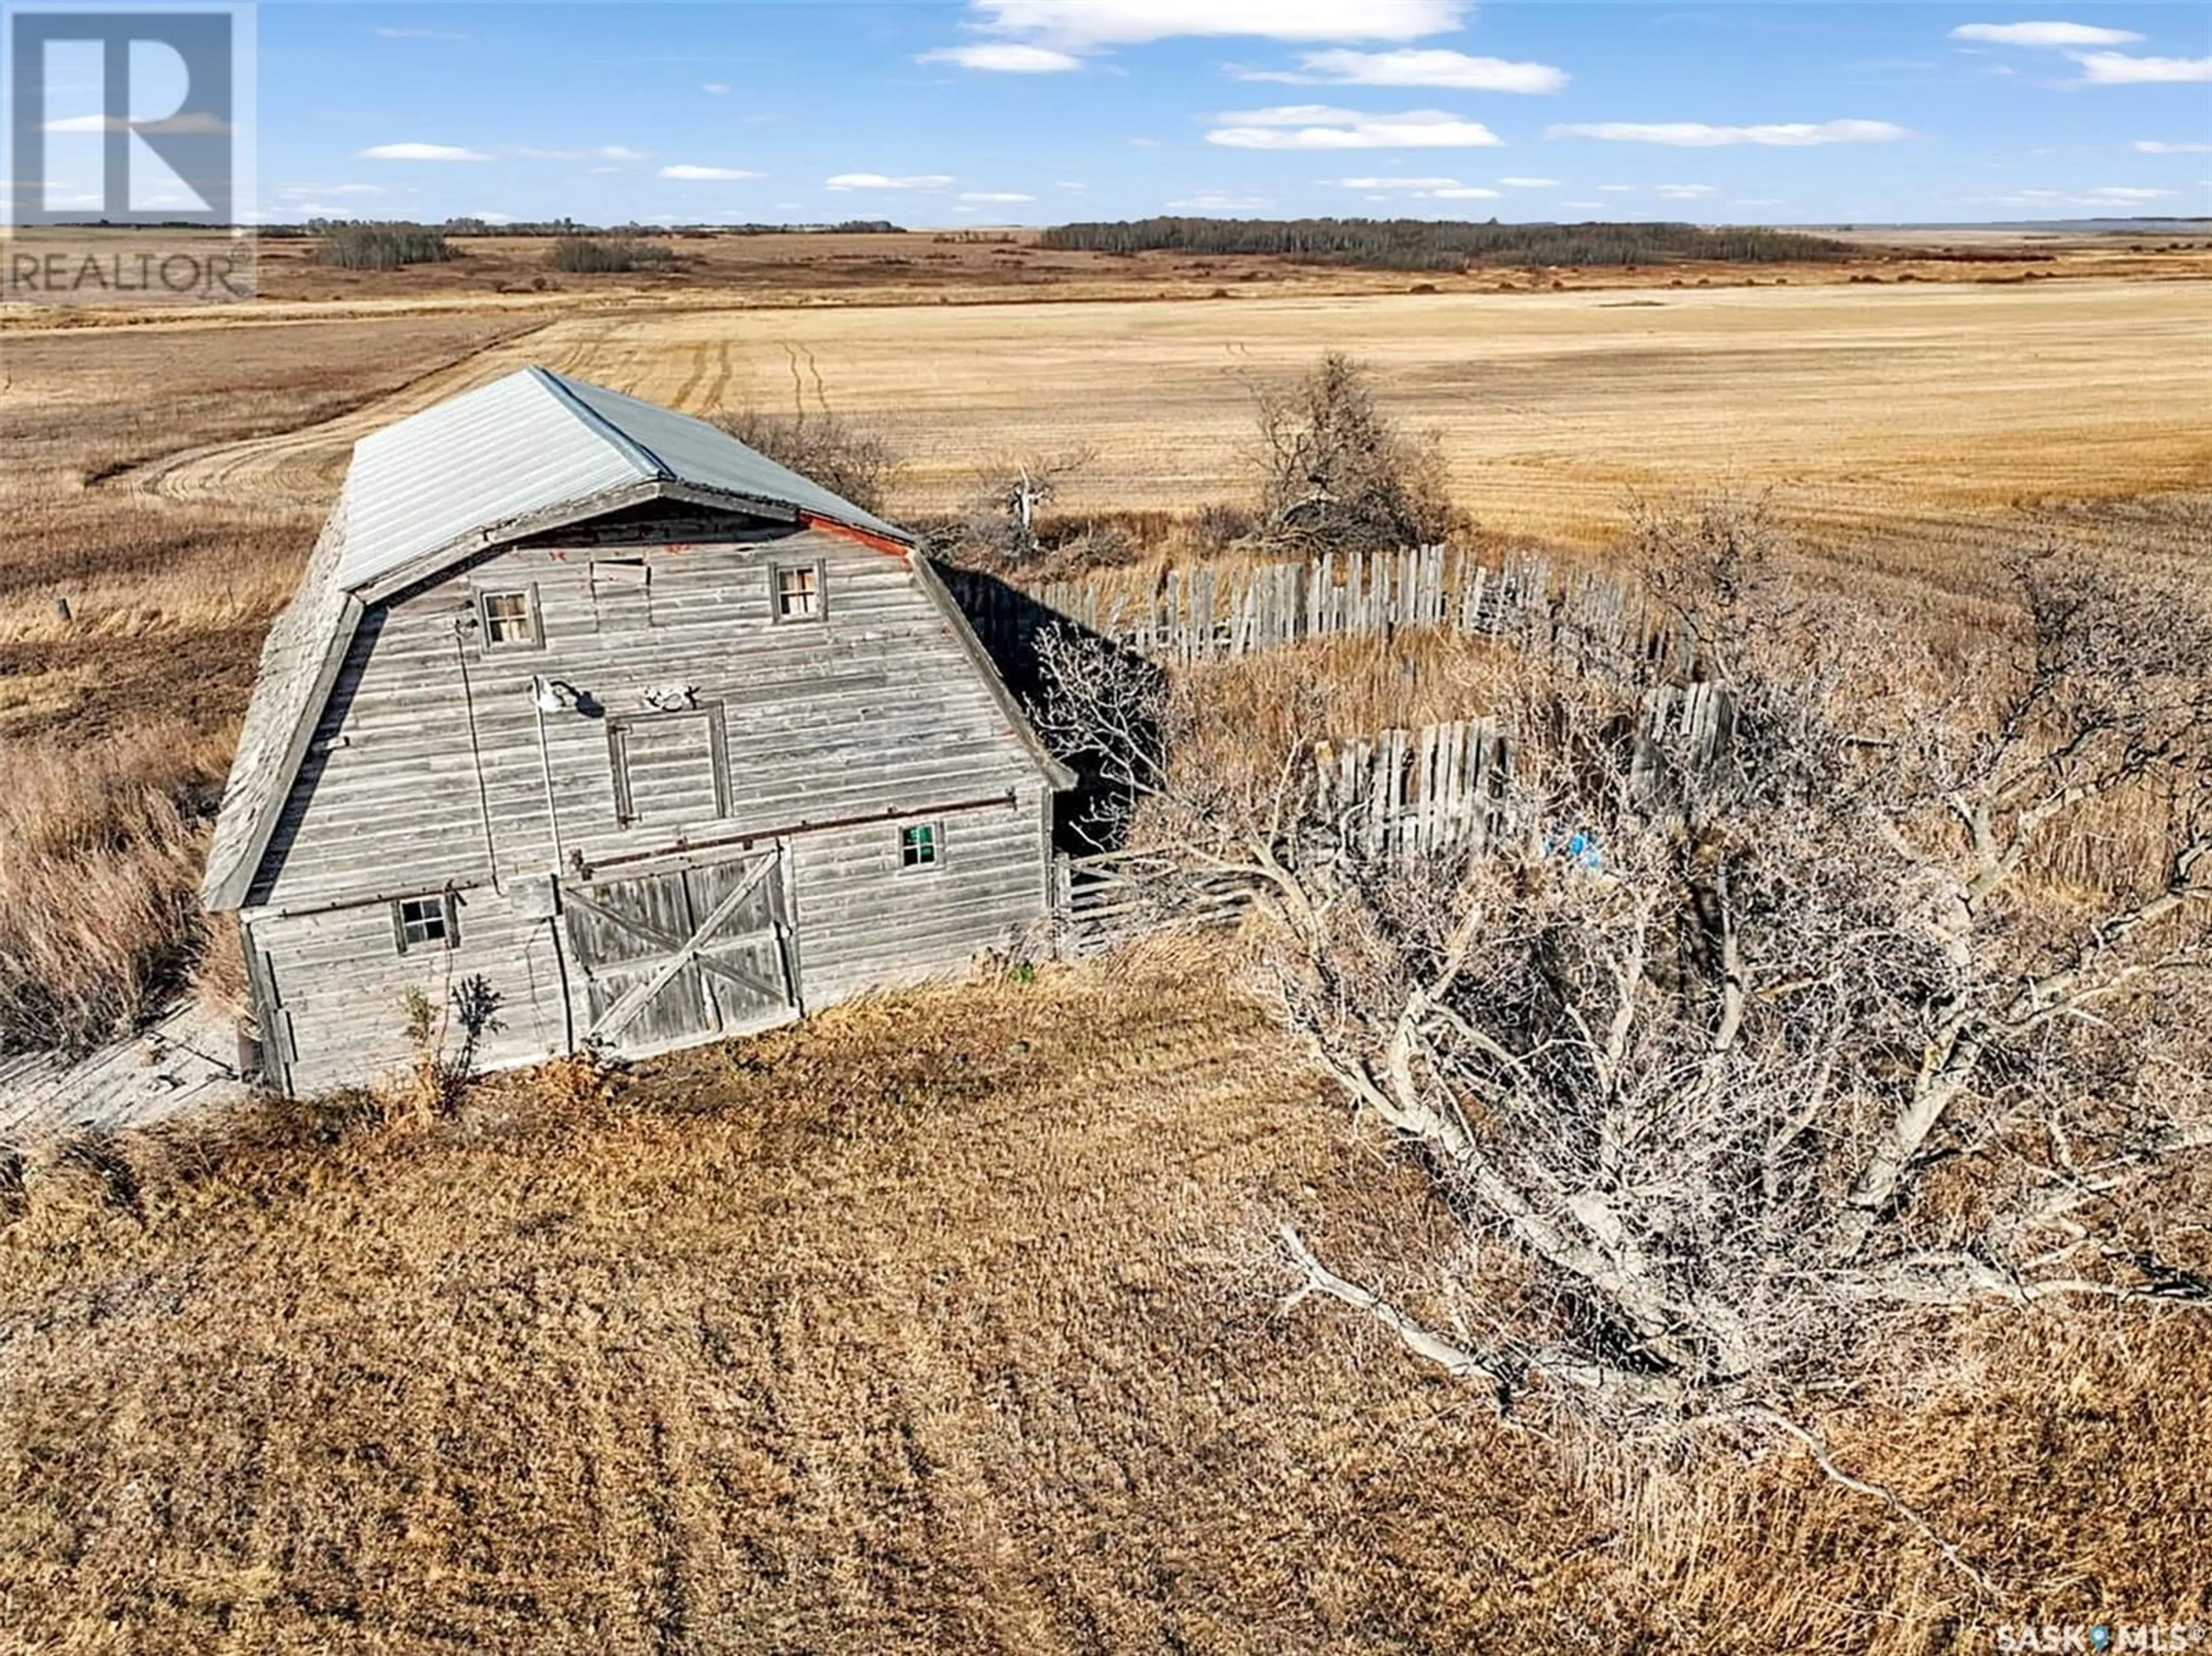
[201,367,1071,1092]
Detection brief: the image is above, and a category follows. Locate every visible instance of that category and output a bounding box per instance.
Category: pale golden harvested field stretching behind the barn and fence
[13,265,2212,546]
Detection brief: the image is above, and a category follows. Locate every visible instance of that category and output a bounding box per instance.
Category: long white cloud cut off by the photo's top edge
[974,0,1469,51]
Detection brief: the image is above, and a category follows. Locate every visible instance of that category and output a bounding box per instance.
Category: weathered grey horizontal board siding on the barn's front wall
[245,517,1048,1090]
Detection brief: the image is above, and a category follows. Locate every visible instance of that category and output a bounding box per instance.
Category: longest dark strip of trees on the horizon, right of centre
[1040,217,1849,270]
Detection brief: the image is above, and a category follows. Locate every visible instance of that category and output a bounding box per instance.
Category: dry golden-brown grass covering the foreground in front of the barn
[0,951,2212,1656]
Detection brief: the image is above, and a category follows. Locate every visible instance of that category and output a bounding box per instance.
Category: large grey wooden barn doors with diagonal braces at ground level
[566,851,798,1055]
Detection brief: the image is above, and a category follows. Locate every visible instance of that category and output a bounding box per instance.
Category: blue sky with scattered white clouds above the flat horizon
[259,0,2212,226]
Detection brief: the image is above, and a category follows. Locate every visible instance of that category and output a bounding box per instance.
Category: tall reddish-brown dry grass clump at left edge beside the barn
[0,723,230,1048]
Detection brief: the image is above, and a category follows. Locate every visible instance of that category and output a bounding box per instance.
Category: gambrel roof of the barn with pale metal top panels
[201,367,1058,909]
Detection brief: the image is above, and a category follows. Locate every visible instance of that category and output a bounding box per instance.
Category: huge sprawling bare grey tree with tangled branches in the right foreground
[1046,497,2212,1468]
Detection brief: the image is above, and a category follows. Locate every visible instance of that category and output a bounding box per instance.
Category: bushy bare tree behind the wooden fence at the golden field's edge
[1254,351,1456,551]
